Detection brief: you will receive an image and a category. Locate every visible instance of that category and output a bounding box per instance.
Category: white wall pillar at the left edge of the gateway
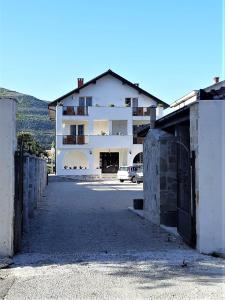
[0,99,16,256]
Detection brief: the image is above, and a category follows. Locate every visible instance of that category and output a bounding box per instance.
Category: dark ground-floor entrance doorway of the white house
[100,152,119,173]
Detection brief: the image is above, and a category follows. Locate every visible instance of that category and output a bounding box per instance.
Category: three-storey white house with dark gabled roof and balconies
[49,70,168,176]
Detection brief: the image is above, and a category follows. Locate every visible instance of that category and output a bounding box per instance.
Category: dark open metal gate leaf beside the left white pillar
[13,150,23,253]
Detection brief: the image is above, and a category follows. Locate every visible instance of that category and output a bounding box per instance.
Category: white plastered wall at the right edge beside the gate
[191,100,225,253]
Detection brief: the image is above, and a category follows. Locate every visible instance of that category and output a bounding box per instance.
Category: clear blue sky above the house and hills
[0,0,224,103]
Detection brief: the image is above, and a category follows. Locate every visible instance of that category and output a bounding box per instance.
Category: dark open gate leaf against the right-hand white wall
[177,125,196,247]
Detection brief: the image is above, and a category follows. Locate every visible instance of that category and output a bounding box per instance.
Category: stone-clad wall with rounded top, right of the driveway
[144,129,177,226]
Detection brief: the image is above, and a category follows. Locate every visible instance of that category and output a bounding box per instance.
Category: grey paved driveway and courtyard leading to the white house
[0,181,225,299]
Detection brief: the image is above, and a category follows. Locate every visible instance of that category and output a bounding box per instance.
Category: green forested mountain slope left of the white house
[0,88,54,149]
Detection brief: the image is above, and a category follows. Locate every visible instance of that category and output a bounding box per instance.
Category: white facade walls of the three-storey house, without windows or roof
[56,76,152,175]
